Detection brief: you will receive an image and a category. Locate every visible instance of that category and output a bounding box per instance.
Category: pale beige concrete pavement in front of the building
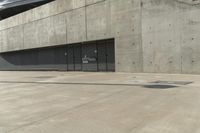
[0,72,200,133]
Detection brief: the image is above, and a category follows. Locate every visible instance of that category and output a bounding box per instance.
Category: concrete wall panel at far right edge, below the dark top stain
[180,8,200,74]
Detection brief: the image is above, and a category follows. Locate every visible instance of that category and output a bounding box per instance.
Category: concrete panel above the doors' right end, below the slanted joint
[86,2,110,40]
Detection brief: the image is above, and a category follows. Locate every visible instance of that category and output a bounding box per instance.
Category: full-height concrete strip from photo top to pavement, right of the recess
[110,0,143,72]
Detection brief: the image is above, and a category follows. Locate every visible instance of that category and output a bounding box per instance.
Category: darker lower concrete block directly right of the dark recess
[115,36,142,72]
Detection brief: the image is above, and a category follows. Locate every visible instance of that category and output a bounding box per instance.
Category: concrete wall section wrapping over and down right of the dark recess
[0,0,142,72]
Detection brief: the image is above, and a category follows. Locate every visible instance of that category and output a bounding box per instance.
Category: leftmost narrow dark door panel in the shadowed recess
[67,46,74,71]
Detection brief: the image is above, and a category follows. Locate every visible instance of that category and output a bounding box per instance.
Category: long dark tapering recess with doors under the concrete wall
[0,39,115,72]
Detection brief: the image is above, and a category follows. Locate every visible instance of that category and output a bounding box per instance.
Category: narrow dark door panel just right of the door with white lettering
[97,41,107,71]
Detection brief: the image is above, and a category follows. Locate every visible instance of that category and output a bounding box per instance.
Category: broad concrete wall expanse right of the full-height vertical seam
[142,0,200,74]
